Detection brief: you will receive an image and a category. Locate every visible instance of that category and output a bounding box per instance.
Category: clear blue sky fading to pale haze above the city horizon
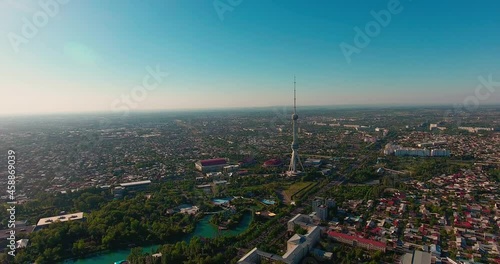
[0,0,500,114]
